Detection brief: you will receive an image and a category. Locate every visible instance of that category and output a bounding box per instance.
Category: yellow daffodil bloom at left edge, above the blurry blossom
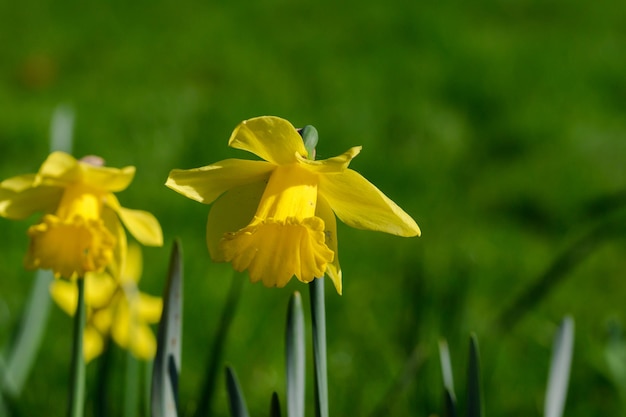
[0,152,163,278]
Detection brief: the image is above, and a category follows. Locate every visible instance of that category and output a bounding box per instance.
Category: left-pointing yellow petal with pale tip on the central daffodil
[165,159,276,204]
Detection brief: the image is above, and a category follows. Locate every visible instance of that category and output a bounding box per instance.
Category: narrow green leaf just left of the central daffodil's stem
[285,291,305,417]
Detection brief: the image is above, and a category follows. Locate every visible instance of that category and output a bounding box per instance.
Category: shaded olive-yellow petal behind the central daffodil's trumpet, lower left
[206,181,266,262]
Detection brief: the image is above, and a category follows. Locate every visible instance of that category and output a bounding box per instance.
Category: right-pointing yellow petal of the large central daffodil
[319,169,420,237]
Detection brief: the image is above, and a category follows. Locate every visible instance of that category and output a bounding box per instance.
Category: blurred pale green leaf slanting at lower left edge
[1,270,54,397]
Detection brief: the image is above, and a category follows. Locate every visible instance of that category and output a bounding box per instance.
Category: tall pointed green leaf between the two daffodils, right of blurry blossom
[150,240,183,417]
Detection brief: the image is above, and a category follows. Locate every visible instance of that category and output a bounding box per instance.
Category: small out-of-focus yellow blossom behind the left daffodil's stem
[50,245,163,362]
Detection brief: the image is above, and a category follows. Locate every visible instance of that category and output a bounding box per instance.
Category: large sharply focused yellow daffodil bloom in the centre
[166,116,420,294]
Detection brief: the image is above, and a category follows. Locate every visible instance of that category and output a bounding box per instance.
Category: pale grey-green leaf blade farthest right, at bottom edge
[543,316,574,417]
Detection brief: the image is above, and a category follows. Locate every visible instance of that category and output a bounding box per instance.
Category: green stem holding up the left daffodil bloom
[67,277,86,417]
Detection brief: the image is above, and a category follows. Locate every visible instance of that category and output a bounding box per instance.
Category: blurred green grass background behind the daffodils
[0,0,626,417]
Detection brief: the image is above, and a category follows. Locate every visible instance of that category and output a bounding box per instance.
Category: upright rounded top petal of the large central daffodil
[228,116,308,165]
